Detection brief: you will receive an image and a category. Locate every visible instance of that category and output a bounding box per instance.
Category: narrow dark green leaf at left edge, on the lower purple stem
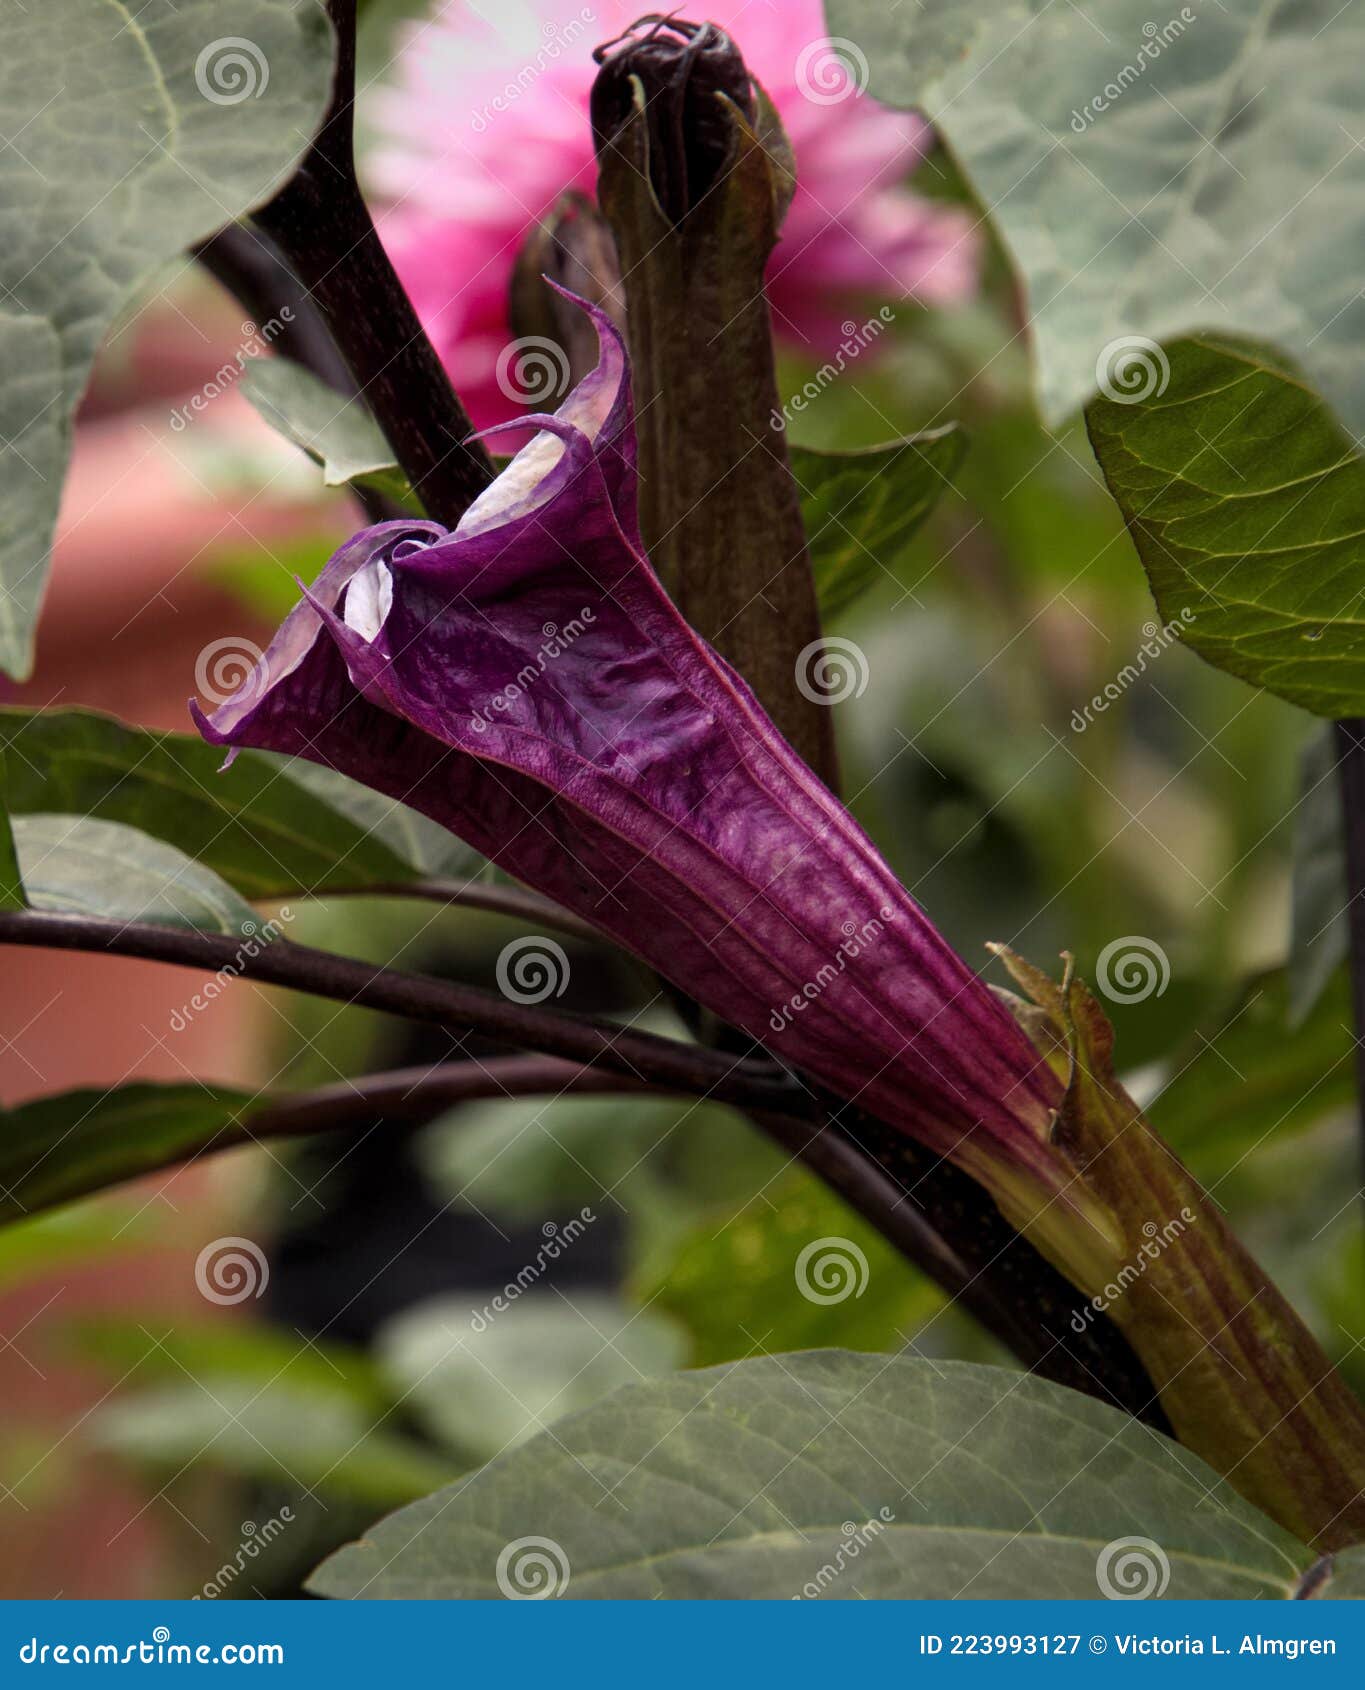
[0,1081,267,1225]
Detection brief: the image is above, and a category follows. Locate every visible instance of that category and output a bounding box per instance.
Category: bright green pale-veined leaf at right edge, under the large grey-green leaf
[1086,336,1365,717]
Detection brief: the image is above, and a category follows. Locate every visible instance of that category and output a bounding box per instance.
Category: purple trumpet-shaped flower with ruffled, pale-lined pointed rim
[191,306,1107,1254]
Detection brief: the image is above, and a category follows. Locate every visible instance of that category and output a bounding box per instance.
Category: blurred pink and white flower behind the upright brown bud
[372,0,976,428]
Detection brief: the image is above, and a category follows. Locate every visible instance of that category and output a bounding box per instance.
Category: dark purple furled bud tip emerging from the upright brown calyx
[590,12,753,223]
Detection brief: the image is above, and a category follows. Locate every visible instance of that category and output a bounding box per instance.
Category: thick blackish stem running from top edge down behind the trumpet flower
[253,0,493,527]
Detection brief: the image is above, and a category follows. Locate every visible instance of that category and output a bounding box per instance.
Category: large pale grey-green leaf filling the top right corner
[826,0,1365,444]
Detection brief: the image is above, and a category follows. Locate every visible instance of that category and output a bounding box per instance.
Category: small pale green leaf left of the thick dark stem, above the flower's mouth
[242,358,421,512]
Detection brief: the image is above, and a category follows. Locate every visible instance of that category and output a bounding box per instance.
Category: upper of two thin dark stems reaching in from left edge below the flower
[0,909,809,1115]
